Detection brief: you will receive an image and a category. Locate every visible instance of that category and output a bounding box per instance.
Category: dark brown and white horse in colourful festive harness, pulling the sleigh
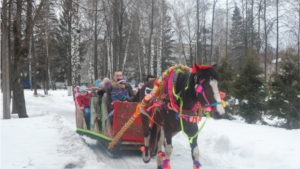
[139,64,225,169]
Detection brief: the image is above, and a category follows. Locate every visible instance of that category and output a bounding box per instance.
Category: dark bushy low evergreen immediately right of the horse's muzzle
[232,56,266,124]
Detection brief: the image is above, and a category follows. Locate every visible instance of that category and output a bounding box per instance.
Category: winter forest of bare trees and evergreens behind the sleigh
[1,0,300,129]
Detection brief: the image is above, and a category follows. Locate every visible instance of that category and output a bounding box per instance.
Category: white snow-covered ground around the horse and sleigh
[0,90,300,169]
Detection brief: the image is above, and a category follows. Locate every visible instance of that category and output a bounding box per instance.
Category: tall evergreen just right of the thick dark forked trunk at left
[34,1,60,95]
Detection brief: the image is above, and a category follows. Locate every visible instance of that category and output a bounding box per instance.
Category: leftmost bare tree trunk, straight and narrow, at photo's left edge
[1,0,11,119]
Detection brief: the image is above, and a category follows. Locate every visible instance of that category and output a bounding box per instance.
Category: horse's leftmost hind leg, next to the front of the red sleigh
[141,114,151,163]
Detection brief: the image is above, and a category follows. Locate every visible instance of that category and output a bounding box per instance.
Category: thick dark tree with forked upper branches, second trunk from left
[13,0,45,118]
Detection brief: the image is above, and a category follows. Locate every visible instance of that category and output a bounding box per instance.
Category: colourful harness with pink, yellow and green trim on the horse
[140,64,222,143]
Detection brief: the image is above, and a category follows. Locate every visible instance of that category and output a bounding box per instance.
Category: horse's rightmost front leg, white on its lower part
[186,124,201,169]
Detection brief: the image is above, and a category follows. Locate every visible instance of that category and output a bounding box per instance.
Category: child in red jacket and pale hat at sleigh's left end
[76,86,92,129]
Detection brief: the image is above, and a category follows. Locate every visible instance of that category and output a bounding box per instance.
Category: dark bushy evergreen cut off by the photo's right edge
[268,54,300,129]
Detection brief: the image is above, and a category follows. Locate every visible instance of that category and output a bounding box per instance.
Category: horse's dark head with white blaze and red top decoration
[192,64,225,119]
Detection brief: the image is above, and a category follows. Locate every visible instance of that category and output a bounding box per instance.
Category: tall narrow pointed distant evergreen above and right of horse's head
[228,5,245,68]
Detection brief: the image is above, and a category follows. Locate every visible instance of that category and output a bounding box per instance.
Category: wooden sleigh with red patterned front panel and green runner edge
[74,87,144,157]
